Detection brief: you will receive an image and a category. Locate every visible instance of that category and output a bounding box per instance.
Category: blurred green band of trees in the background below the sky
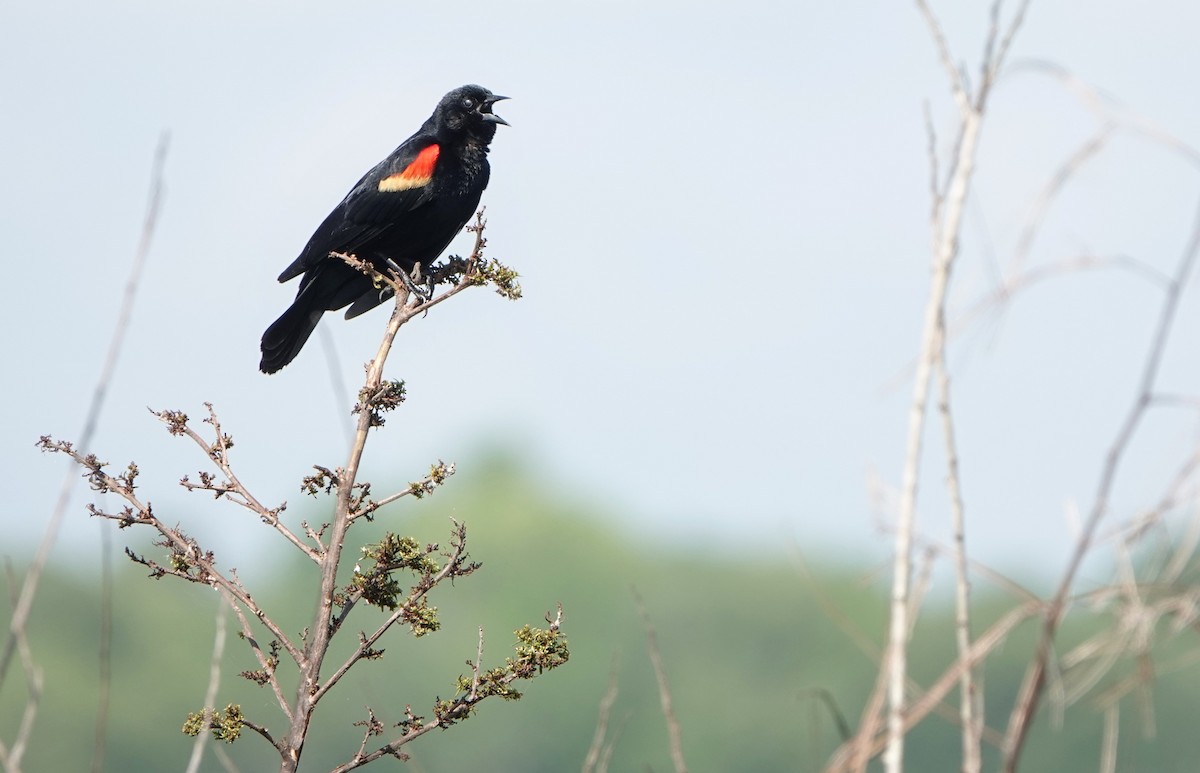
[0,457,1200,773]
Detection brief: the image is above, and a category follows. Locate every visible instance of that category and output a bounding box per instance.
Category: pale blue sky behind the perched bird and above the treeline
[0,0,1200,580]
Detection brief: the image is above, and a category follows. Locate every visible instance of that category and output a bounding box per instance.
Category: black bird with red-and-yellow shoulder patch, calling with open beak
[258,85,508,373]
